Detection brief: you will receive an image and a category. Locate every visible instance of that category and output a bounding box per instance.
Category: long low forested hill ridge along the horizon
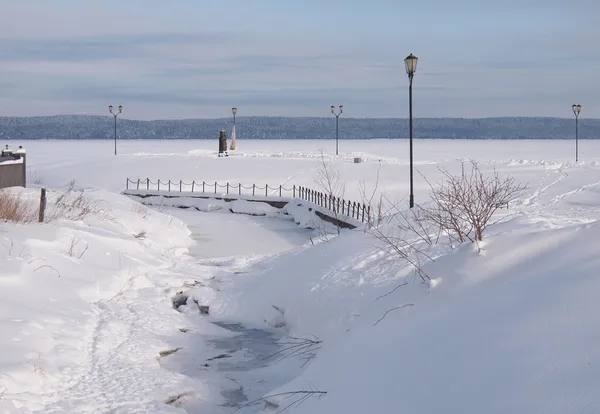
[0,115,600,140]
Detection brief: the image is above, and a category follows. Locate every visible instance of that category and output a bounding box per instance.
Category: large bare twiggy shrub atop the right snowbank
[423,161,527,243]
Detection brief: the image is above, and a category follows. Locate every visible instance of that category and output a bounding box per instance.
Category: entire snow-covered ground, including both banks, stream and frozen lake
[0,139,600,414]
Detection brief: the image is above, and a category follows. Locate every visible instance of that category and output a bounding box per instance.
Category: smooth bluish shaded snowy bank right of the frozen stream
[196,213,600,414]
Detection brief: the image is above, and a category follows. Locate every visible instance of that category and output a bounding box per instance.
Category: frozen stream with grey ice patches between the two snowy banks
[155,209,312,414]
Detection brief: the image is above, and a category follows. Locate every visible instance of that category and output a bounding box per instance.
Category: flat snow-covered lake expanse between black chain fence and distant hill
[14,139,600,205]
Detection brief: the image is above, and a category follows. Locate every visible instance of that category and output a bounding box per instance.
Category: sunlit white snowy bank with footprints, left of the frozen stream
[0,189,202,413]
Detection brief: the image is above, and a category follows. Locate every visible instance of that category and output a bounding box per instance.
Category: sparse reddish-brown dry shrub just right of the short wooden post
[46,180,110,221]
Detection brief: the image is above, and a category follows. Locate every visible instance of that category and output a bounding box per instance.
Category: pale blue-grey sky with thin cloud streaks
[0,0,600,120]
